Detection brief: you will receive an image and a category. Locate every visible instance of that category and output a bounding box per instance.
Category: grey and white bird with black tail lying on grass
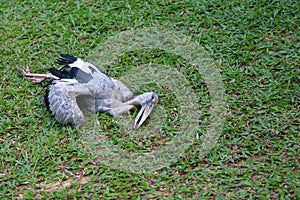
[16,54,159,130]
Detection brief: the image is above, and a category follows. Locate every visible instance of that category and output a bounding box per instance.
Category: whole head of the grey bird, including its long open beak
[133,92,158,130]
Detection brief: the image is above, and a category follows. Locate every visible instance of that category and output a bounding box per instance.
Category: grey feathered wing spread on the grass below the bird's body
[46,79,95,127]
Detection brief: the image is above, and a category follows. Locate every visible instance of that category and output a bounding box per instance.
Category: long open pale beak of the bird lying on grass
[133,93,158,130]
